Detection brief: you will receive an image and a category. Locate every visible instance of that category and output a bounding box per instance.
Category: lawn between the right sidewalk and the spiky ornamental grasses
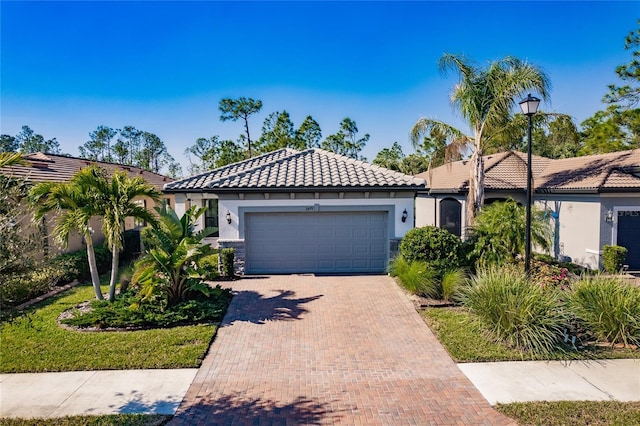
[421,307,640,362]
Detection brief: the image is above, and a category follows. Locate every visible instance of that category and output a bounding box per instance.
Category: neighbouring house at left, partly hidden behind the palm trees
[0,152,175,252]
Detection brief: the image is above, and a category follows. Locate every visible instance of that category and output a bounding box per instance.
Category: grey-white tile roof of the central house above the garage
[164,148,425,192]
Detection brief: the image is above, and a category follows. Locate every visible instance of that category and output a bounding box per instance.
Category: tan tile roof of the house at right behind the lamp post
[417,149,640,192]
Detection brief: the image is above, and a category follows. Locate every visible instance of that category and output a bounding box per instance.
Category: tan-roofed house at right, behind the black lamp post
[416,149,640,271]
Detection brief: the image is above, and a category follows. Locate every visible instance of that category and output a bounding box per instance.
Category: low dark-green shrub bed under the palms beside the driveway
[62,286,232,328]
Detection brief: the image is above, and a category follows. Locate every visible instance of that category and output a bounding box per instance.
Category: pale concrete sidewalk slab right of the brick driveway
[458,359,640,405]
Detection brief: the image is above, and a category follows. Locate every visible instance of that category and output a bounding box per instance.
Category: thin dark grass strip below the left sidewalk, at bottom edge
[0,414,171,426]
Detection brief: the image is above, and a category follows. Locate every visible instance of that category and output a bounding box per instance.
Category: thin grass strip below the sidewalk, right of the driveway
[496,401,640,426]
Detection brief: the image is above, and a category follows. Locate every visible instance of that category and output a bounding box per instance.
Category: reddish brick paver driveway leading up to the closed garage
[170,275,512,425]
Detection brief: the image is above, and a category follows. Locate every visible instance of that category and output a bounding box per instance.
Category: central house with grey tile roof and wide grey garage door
[164,148,425,274]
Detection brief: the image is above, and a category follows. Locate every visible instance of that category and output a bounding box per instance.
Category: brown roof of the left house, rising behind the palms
[0,152,173,191]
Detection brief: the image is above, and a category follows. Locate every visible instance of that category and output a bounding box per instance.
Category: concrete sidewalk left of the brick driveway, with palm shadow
[0,368,198,418]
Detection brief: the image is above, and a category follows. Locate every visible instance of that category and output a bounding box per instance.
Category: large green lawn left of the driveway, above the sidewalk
[0,284,216,373]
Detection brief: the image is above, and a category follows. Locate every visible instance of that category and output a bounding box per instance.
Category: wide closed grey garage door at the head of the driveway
[245,212,389,274]
